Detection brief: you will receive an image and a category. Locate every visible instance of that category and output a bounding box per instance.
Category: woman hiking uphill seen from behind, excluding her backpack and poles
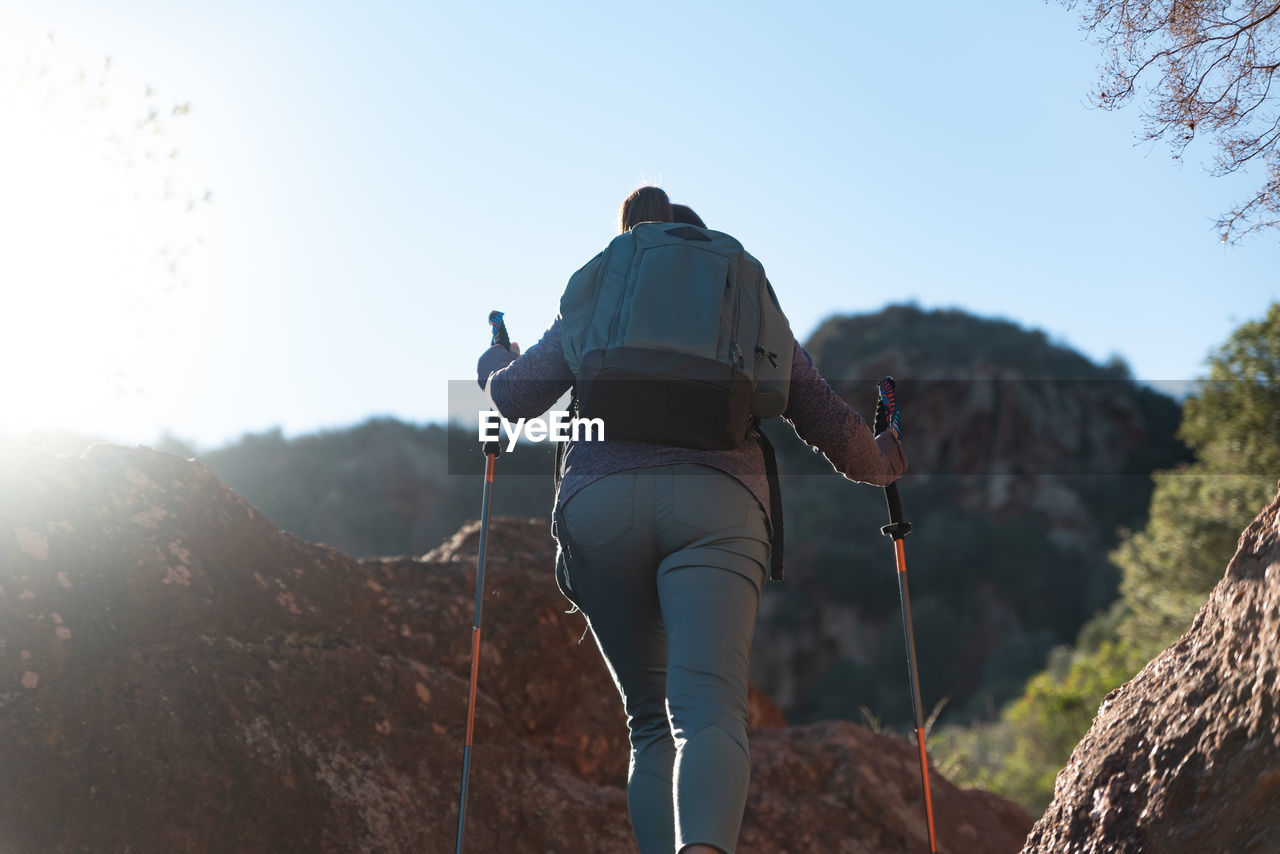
[477,187,906,854]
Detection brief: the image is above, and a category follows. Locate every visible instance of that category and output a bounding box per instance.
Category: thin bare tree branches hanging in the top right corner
[1066,0,1280,242]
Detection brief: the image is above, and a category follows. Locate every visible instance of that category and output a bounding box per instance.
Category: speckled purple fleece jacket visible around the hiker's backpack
[477,318,906,524]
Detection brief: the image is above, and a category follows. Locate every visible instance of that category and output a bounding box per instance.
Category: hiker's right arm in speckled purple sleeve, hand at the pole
[782,342,906,487]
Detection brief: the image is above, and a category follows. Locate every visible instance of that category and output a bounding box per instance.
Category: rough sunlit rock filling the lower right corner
[1024,483,1280,854]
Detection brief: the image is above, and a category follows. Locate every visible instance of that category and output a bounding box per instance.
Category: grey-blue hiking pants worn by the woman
[557,465,769,854]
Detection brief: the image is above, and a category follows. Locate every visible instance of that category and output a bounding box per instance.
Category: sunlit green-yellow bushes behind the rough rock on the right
[934,305,1280,813]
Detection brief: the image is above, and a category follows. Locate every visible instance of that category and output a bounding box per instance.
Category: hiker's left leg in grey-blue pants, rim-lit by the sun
[563,471,676,854]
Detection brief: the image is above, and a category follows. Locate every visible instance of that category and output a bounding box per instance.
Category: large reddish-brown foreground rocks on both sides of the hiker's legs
[0,446,1030,854]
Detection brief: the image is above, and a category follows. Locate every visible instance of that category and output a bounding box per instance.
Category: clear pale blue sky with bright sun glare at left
[0,0,1280,448]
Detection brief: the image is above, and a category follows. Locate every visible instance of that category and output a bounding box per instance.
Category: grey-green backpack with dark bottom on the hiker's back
[561,223,795,449]
